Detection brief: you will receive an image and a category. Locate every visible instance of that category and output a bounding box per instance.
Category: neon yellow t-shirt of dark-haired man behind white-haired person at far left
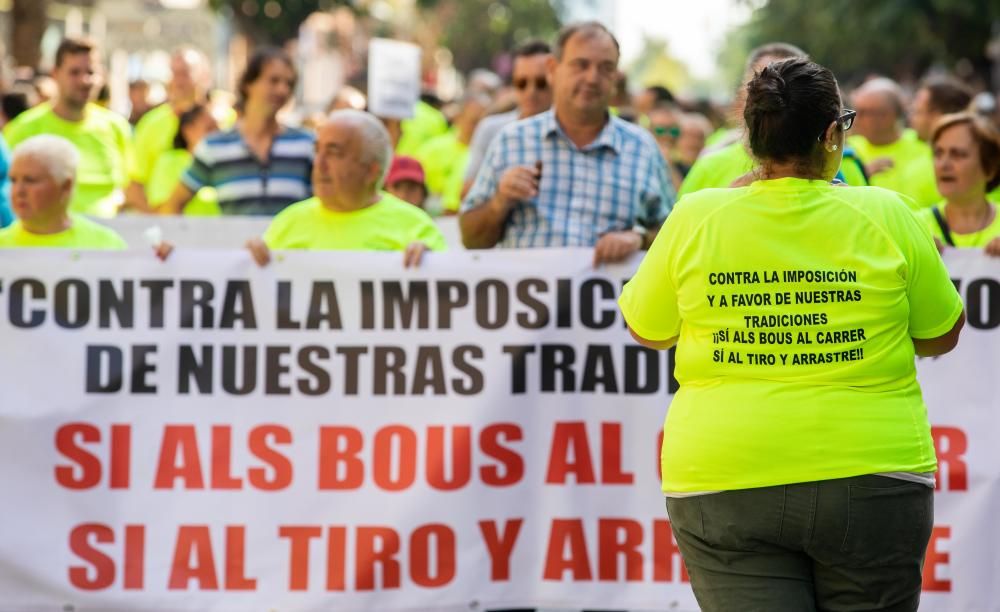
[3,102,132,217]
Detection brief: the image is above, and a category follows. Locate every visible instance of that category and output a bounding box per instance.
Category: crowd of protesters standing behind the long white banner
[0,22,1000,263]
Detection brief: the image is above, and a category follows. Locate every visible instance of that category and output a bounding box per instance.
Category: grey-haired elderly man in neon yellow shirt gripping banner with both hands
[247,110,446,267]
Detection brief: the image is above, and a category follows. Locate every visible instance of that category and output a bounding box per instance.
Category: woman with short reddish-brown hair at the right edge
[917,113,1000,257]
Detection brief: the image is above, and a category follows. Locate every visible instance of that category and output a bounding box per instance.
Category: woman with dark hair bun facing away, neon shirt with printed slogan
[620,58,965,612]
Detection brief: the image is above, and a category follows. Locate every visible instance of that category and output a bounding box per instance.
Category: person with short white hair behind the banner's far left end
[0,134,127,250]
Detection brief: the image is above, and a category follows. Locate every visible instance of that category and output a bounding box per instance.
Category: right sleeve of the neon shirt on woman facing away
[900,211,963,339]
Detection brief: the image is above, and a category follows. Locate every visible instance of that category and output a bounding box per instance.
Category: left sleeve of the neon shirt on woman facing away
[618,215,684,340]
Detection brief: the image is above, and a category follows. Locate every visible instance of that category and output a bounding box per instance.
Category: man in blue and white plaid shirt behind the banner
[460,22,674,264]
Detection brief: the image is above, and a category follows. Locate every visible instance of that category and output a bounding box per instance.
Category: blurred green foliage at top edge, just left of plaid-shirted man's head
[417,0,560,72]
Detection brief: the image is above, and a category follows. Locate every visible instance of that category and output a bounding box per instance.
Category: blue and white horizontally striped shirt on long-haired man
[181,127,315,215]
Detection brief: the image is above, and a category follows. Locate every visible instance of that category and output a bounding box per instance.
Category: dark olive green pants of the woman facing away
[667,476,934,612]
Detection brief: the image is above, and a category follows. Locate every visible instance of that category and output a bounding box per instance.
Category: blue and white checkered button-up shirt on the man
[462,110,675,248]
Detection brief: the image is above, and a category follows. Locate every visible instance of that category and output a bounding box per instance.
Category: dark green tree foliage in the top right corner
[731,0,1000,85]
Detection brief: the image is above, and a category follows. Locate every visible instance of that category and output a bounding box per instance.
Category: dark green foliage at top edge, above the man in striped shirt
[209,0,336,45]
